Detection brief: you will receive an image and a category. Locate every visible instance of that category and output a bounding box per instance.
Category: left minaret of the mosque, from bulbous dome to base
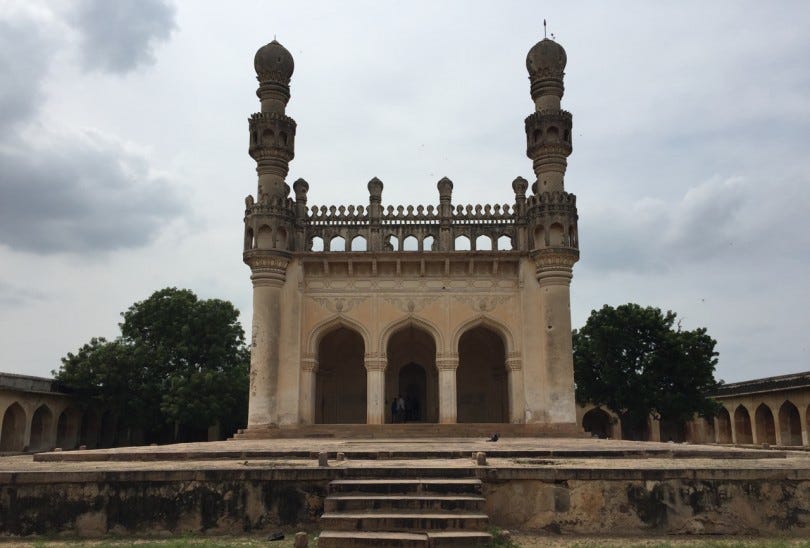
[243,40,298,429]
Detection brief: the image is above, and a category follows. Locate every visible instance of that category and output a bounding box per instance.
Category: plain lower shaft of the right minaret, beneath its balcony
[532,248,579,423]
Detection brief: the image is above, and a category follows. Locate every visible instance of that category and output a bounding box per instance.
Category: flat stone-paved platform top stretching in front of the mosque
[0,438,810,475]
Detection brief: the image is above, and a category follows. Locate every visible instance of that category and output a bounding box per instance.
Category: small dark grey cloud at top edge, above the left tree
[71,0,176,73]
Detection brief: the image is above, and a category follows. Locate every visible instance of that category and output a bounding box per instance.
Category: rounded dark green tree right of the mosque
[573,303,717,438]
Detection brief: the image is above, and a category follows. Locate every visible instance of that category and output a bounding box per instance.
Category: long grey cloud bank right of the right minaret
[580,174,810,272]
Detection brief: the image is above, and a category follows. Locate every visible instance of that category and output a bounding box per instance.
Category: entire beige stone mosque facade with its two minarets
[240,35,581,437]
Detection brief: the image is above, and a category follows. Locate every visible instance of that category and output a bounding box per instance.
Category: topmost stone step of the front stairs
[329,478,483,495]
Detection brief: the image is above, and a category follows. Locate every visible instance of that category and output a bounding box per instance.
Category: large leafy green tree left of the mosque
[54,288,250,441]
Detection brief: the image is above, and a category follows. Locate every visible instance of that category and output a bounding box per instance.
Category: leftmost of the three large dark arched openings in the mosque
[315,327,367,424]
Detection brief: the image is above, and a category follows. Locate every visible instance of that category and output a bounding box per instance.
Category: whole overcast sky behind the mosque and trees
[0,0,810,382]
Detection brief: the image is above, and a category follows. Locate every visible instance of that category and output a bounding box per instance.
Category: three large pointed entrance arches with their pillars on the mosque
[301,317,523,424]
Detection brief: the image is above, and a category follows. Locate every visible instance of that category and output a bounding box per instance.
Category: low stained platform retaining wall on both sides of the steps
[0,468,810,537]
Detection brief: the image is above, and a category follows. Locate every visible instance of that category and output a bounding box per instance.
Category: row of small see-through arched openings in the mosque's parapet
[309,234,514,251]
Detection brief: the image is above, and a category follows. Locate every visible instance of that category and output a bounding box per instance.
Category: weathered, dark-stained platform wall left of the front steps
[0,470,328,537]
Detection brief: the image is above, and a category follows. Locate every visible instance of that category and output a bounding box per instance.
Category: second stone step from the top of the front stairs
[324,494,486,512]
